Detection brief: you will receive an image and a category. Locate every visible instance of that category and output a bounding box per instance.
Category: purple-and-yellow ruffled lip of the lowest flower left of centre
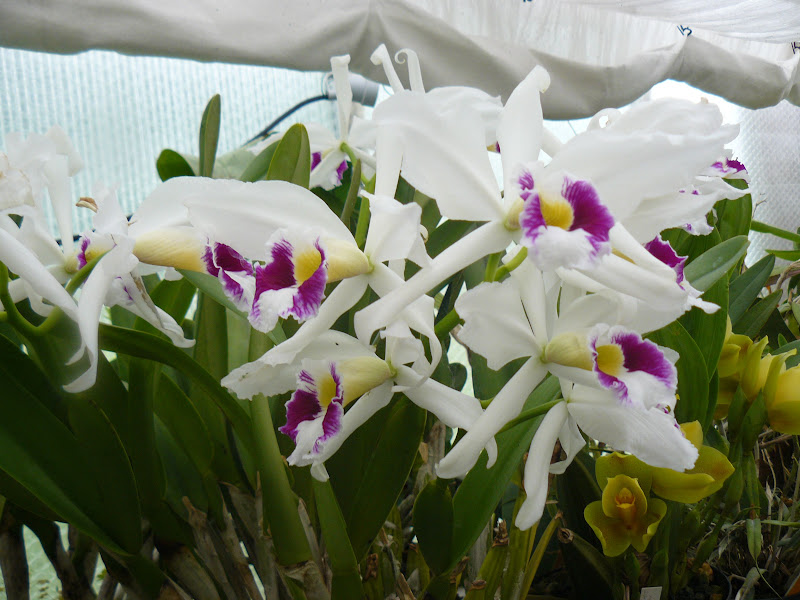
[278,362,344,452]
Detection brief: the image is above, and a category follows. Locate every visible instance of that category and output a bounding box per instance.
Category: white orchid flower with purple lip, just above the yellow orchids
[437,263,696,527]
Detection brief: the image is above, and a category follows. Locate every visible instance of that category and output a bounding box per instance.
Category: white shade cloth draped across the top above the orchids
[0,0,800,119]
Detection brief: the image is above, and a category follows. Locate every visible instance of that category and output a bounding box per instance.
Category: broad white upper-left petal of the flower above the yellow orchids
[456,280,540,370]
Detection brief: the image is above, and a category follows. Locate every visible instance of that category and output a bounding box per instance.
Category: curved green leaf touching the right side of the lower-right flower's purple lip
[648,321,709,423]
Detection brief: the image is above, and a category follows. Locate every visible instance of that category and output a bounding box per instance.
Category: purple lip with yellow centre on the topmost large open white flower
[516,170,614,271]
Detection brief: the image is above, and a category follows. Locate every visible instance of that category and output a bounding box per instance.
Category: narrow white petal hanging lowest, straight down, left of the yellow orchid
[514,402,567,530]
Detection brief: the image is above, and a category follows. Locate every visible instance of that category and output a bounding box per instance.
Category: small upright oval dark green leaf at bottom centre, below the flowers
[413,479,453,575]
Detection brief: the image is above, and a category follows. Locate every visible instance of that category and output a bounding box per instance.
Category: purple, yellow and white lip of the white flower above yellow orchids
[589,324,678,406]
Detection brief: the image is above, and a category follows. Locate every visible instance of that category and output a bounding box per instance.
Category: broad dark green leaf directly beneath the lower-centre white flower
[326,398,426,557]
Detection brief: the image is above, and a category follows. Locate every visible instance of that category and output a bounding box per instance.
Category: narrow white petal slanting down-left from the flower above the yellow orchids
[436,358,547,479]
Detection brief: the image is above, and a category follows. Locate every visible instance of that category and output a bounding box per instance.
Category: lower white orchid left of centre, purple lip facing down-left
[222,321,490,479]
